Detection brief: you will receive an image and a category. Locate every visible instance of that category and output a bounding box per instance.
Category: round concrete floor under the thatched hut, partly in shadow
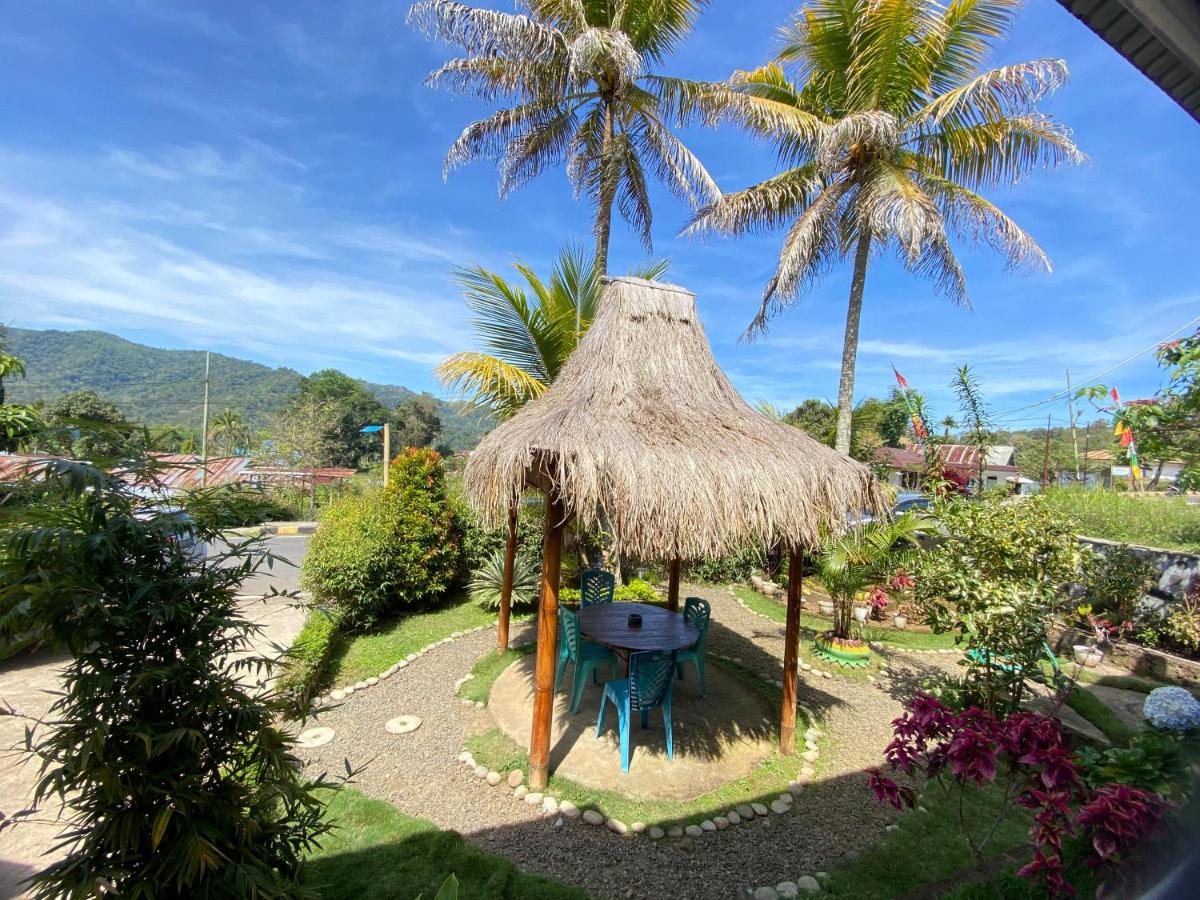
[488,656,779,800]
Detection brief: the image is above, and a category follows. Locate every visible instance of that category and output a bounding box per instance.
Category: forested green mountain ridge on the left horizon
[5,328,487,450]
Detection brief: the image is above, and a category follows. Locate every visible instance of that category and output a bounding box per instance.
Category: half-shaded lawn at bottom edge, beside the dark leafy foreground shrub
[307,787,587,900]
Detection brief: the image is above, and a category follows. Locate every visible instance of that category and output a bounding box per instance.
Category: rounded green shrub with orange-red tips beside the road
[301,448,460,629]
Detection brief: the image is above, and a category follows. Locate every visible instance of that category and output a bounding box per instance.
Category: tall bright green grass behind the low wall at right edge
[1045,487,1200,553]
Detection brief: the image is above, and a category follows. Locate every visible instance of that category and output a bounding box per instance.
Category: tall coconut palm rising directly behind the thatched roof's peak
[409,0,720,275]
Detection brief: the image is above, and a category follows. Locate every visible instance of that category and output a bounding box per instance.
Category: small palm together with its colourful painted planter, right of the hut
[814,512,931,666]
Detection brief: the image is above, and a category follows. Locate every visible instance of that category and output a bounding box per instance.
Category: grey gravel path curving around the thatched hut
[299,586,964,900]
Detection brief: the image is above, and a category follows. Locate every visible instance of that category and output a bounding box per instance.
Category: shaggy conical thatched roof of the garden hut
[464,278,882,559]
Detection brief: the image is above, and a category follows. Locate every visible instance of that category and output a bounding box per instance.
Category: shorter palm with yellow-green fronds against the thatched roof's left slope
[437,247,667,420]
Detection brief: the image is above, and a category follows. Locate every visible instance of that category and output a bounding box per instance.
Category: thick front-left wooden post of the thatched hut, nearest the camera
[529,496,565,791]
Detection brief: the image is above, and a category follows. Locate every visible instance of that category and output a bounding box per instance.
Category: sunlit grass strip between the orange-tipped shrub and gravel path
[330,596,528,684]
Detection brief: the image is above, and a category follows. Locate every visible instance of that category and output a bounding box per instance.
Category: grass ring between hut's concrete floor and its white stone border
[467,650,820,828]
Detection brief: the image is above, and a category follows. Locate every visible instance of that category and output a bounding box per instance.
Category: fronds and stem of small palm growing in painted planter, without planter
[816,511,934,640]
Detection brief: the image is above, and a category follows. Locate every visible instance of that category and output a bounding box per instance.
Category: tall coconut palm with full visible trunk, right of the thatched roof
[685,0,1084,452]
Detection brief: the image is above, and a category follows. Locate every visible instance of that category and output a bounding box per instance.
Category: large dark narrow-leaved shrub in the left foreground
[0,448,330,898]
